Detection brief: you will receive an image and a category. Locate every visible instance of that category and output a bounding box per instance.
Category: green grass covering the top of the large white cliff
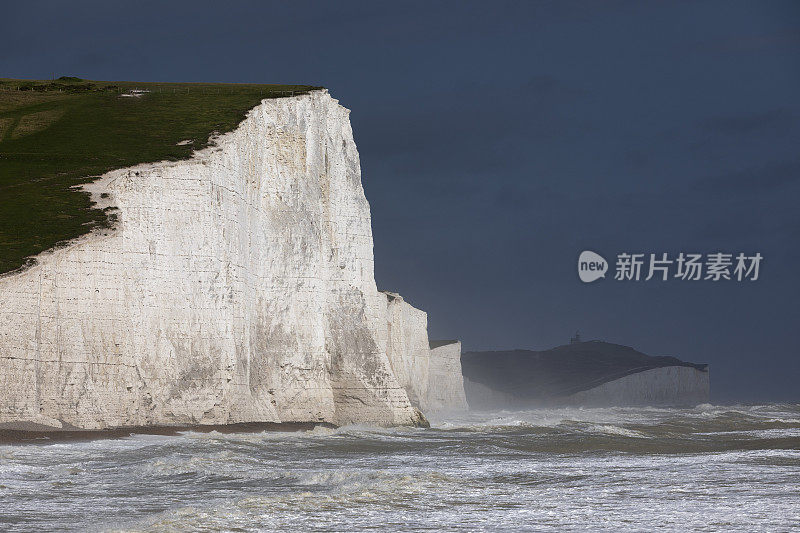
[0,78,316,273]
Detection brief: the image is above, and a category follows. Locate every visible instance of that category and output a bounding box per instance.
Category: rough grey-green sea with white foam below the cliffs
[0,404,800,532]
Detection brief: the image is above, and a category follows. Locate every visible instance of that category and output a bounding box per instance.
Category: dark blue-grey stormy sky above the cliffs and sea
[0,1,800,401]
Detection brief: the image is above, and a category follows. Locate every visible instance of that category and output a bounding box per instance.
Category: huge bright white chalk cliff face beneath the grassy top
[0,91,428,429]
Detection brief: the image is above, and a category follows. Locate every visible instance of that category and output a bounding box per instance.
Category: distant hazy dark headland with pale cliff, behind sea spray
[462,341,709,410]
